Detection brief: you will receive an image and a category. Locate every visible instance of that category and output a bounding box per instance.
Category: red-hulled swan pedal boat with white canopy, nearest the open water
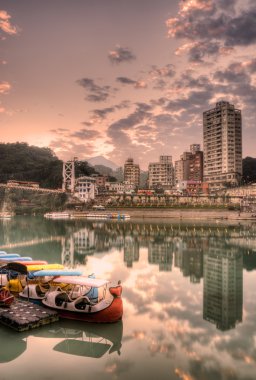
[42,276,123,323]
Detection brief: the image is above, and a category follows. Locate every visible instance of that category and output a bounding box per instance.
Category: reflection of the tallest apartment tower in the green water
[203,241,243,331]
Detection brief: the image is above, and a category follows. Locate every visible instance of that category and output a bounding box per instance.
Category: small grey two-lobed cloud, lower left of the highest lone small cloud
[76,78,115,102]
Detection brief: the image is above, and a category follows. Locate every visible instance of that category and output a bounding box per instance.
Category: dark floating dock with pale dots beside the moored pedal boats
[0,299,59,331]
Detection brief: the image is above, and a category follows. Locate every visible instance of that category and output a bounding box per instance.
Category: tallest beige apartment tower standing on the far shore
[203,101,242,189]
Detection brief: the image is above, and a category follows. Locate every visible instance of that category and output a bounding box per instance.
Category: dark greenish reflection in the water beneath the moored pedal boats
[0,320,123,363]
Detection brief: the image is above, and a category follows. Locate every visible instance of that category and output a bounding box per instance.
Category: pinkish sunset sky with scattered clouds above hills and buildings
[0,0,256,170]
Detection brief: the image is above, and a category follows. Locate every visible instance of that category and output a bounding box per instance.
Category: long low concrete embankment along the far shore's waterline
[108,208,256,221]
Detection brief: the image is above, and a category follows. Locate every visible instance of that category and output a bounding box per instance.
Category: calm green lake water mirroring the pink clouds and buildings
[0,217,256,380]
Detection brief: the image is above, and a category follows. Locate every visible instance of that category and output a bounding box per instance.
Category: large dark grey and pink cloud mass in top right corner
[166,0,256,62]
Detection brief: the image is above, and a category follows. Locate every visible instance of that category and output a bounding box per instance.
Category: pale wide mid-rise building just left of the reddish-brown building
[148,156,174,189]
